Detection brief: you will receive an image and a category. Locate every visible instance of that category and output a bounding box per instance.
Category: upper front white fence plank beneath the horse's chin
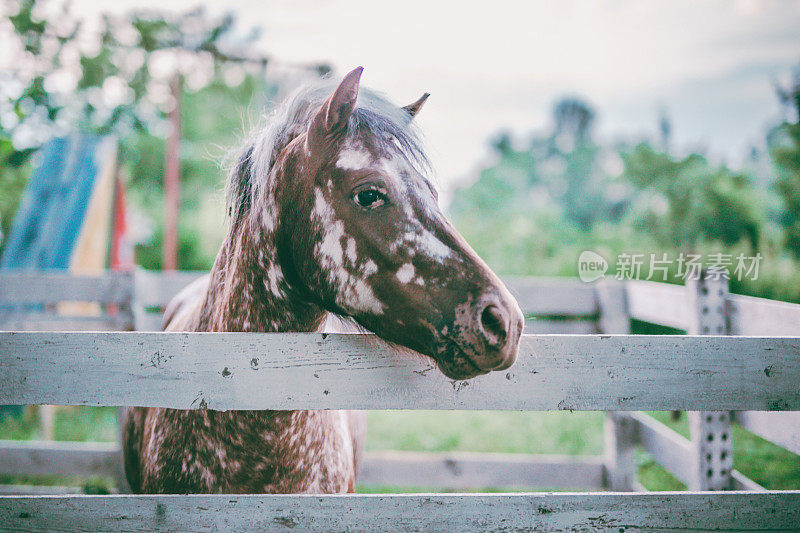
[0,332,800,411]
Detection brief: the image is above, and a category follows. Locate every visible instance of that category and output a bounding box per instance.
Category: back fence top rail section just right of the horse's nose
[503,277,598,316]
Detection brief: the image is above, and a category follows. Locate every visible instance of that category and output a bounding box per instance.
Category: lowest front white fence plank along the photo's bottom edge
[0,491,800,532]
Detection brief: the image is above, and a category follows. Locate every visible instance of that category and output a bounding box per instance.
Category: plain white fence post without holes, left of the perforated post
[595,280,638,491]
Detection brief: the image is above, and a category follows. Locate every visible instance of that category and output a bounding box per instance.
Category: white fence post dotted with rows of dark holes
[686,272,733,490]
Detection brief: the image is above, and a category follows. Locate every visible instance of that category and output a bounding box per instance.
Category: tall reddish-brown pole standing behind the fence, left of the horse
[162,74,182,270]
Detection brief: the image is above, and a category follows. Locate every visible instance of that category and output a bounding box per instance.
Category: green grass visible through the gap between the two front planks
[0,407,800,492]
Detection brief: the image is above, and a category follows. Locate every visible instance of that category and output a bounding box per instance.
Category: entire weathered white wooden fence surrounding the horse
[0,272,800,530]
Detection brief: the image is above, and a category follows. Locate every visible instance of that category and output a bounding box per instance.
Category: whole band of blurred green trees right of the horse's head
[450,92,800,302]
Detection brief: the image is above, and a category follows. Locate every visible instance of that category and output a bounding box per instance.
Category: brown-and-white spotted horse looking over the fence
[123,67,523,494]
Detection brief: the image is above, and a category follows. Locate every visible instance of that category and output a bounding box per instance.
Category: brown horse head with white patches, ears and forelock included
[242,67,523,379]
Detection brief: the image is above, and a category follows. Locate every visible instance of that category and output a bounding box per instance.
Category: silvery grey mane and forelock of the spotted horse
[226,79,430,226]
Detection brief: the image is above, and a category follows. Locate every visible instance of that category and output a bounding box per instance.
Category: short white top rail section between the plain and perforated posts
[625,281,690,330]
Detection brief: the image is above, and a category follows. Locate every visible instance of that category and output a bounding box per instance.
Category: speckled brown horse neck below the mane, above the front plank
[197,217,327,332]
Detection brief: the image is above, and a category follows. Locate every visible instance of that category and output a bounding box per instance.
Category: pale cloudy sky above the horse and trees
[64,0,800,188]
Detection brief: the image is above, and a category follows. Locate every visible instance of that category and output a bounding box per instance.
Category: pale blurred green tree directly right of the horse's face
[449,98,619,275]
